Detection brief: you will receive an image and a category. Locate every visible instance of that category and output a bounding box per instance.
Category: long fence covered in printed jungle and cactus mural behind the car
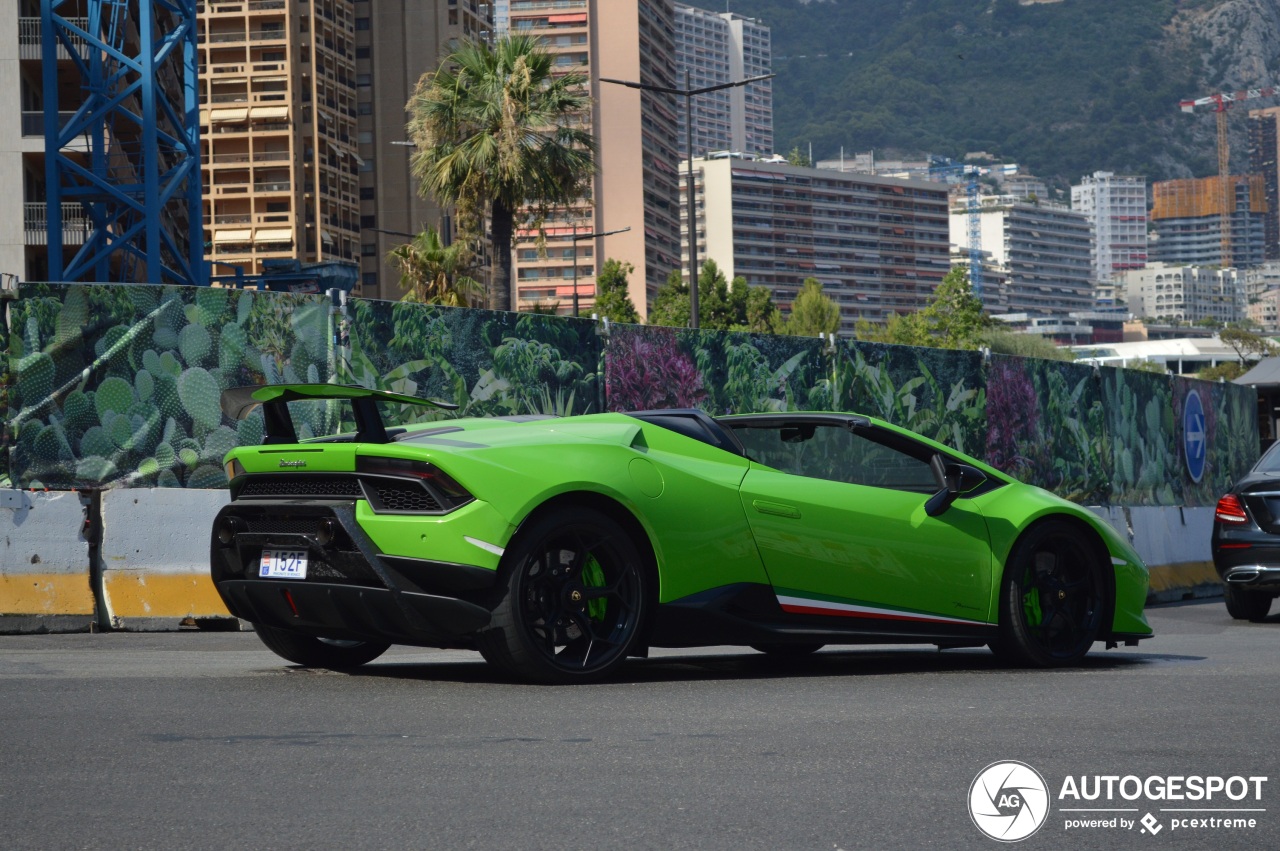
[0,284,1258,505]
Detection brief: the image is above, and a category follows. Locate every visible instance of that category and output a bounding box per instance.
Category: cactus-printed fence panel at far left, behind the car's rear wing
[5,284,332,488]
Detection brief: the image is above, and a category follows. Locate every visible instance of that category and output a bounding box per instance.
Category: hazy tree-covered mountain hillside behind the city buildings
[692,0,1280,188]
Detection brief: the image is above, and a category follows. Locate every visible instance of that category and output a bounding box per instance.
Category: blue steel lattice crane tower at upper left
[40,0,209,285]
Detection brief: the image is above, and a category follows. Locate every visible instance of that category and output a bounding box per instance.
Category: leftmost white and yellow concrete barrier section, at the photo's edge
[0,489,95,632]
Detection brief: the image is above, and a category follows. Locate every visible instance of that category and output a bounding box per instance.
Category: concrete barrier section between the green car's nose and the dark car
[1093,505,1222,603]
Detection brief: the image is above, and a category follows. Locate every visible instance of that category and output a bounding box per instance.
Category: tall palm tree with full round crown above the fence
[406,36,595,310]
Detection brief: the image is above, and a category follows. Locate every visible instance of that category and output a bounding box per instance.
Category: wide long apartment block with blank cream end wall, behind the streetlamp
[681,156,951,337]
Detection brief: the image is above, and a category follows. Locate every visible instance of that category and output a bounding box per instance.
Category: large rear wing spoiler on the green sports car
[221,384,458,444]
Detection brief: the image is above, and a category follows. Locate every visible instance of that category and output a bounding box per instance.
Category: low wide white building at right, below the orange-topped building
[1124,262,1247,324]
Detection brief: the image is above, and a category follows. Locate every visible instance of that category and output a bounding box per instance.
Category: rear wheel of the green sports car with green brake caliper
[479,508,652,683]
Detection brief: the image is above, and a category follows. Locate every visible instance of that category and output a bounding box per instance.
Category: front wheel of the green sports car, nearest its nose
[991,520,1111,668]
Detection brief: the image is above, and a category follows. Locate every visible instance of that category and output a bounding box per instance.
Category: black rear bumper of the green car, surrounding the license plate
[210,500,497,646]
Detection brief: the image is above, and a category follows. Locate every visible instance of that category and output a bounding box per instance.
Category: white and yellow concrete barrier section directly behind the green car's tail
[100,488,234,631]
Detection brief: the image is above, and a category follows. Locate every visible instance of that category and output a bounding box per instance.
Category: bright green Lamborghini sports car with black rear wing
[211,384,1151,682]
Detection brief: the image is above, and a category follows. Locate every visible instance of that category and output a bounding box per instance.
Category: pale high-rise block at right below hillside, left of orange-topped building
[1071,171,1147,282]
